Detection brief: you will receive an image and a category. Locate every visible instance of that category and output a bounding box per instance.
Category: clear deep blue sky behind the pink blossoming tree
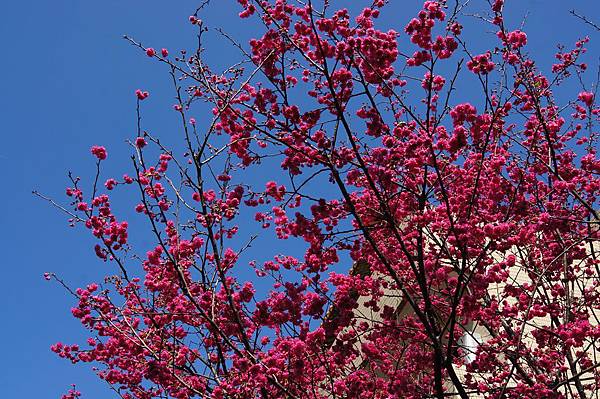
[0,0,600,399]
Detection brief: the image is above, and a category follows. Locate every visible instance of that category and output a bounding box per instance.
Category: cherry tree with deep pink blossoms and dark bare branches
[39,0,600,399]
